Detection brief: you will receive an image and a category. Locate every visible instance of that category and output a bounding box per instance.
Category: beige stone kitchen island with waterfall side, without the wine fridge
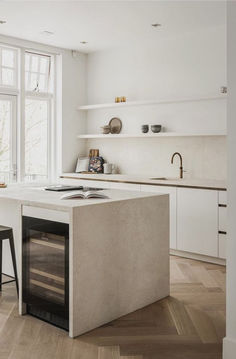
[0,184,170,338]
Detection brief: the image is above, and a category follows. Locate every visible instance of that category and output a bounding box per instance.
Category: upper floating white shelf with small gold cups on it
[78,94,227,111]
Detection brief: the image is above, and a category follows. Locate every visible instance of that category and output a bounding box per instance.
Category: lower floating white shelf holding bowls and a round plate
[77,132,226,139]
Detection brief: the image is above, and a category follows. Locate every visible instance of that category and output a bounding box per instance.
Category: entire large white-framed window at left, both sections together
[0,44,54,182]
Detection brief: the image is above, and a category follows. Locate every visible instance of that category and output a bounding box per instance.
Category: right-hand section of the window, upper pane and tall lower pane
[24,52,52,181]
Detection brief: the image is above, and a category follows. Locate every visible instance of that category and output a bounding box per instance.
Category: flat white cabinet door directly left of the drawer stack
[177,188,218,257]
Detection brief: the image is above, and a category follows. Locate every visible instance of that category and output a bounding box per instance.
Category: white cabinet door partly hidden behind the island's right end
[141,185,177,249]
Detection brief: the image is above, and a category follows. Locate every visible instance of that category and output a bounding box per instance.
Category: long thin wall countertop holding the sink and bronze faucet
[61,173,227,191]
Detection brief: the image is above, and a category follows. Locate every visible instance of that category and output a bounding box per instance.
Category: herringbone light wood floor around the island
[0,257,225,359]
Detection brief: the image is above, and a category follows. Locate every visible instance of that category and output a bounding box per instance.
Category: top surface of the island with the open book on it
[0,184,164,211]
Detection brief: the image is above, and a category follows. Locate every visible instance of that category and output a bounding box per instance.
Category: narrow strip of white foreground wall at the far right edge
[224,1,236,359]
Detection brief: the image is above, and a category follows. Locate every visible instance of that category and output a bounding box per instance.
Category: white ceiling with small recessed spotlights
[0,0,226,53]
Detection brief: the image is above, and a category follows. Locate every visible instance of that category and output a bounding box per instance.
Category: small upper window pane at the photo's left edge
[0,47,17,87]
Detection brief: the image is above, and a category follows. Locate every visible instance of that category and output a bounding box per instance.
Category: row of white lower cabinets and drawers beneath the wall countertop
[59,180,227,258]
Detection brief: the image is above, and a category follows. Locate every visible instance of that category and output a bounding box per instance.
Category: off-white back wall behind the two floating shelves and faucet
[83,27,226,179]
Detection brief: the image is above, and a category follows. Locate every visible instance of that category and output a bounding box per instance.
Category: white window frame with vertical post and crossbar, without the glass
[0,42,58,183]
